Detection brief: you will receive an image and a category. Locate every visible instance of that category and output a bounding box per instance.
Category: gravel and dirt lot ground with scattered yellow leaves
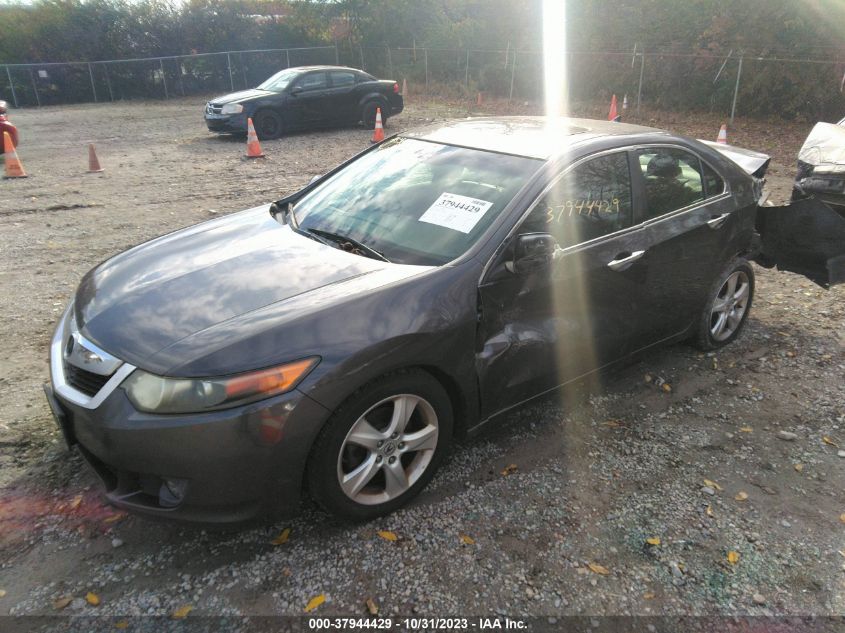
[0,100,845,628]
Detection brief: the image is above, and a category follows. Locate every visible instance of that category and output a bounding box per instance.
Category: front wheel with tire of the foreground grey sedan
[306,370,452,521]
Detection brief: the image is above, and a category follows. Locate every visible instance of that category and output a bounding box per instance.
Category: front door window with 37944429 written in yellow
[520,152,633,248]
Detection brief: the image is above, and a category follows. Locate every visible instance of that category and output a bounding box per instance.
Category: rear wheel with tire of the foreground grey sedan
[695,258,754,351]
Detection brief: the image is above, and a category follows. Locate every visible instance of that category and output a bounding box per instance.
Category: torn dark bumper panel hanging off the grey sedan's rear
[756,198,845,288]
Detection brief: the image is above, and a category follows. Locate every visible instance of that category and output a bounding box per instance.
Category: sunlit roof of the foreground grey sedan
[402,116,669,160]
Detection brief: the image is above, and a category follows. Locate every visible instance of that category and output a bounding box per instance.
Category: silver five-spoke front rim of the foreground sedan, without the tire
[337,394,439,505]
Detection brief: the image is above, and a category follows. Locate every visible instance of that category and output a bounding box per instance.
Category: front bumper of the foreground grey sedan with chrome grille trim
[45,304,329,523]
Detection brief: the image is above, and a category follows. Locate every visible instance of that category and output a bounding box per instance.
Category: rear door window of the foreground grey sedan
[636,147,704,220]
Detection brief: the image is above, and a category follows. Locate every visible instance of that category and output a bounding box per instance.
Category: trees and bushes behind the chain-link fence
[0,0,845,120]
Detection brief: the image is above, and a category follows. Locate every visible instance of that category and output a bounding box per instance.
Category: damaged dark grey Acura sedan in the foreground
[46,118,845,521]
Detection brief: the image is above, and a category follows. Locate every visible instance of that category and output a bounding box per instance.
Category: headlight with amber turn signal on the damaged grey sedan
[122,358,320,413]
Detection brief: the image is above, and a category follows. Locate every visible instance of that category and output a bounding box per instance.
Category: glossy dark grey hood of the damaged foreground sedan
[75,206,427,371]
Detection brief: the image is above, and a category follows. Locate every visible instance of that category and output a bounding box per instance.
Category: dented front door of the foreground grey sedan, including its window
[476,151,643,417]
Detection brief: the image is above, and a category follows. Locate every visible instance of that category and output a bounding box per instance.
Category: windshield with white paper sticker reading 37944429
[293,138,542,265]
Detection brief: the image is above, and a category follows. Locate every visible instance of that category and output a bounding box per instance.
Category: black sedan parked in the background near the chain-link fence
[205,66,404,139]
